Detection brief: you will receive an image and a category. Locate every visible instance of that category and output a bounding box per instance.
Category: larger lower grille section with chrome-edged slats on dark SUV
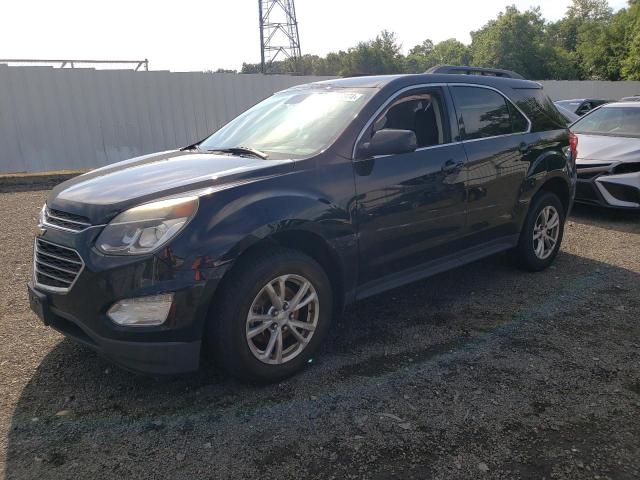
[33,238,84,292]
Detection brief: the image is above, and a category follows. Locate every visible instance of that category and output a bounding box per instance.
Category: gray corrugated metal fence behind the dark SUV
[0,65,640,173]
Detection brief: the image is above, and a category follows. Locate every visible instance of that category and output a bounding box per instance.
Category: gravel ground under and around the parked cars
[0,191,640,480]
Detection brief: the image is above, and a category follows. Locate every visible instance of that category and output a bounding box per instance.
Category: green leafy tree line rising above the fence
[236,0,640,80]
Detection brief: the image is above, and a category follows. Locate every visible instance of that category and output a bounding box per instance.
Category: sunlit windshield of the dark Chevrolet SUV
[198,89,375,158]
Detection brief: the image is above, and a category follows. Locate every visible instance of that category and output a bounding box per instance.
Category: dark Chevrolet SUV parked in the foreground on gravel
[29,68,576,381]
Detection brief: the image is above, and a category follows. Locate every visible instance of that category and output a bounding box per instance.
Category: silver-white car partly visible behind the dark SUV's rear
[570,102,640,210]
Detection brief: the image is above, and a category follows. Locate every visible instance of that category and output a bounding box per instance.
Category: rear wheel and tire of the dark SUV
[512,191,565,272]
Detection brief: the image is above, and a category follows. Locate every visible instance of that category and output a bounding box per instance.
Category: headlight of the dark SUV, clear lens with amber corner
[96,196,198,255]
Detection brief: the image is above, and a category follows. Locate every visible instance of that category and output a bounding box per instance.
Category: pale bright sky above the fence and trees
[0,0,626,71]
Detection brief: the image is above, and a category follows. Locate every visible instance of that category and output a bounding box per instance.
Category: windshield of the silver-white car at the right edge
[571,107,640,137]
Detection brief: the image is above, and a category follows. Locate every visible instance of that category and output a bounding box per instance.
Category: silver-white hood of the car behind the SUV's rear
[576,133,640,162]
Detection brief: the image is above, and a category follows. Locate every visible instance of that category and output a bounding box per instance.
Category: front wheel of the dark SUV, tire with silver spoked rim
[206,247,333,383]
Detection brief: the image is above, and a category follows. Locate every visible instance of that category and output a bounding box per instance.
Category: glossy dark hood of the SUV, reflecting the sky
[47,150,294,223]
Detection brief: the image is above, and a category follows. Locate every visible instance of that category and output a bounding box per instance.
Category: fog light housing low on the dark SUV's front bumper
[107,293,173,327]
